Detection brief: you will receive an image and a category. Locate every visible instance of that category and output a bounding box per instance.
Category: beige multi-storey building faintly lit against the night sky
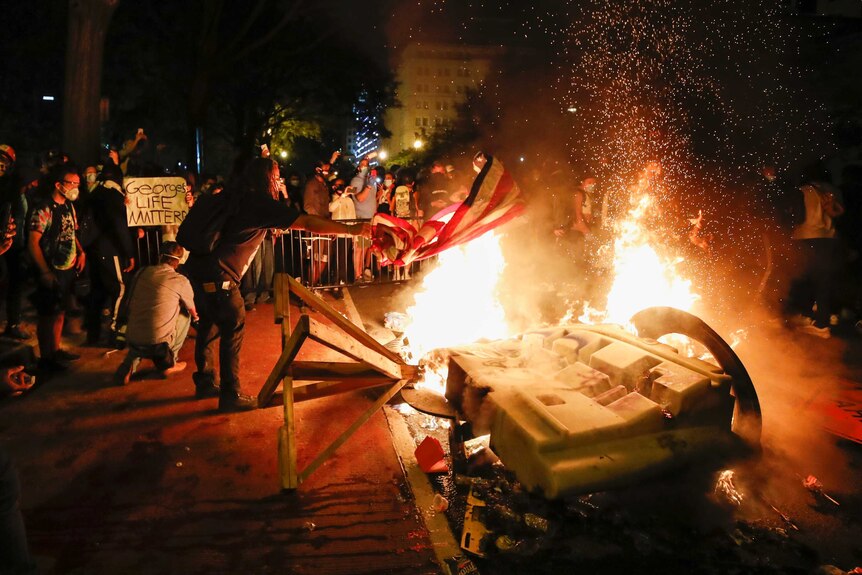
[384,43,503,153]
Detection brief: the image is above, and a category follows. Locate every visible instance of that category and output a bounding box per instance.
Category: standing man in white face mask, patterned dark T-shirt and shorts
[27,164,86,372]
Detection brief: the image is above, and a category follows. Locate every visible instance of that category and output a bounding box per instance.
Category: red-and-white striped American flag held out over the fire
[371,155,524,266]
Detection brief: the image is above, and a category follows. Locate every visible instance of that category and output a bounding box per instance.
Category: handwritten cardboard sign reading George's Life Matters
[123,177,189,226]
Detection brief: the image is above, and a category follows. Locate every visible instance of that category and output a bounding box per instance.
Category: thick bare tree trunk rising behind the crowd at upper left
[63,0,119,167]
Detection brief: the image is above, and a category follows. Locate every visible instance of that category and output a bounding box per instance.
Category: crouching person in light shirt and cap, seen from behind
[114,242,198,385]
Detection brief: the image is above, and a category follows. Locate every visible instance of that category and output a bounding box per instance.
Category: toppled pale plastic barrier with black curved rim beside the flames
[446,308,761,498]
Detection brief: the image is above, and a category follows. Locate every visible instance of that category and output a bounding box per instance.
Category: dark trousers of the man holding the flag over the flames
[192,280,245,400]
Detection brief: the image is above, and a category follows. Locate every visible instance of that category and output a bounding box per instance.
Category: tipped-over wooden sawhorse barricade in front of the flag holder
[257,273,418,489]
